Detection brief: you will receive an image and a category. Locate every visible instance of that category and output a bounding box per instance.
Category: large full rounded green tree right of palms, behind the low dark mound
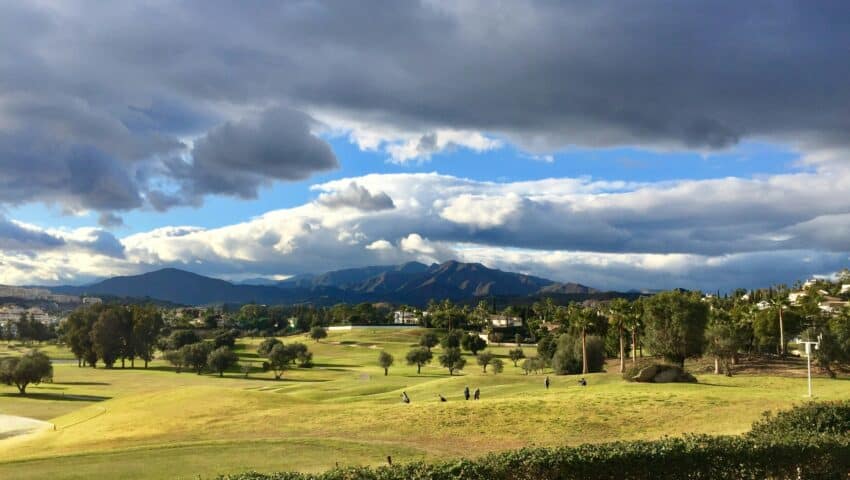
[643,290,708,367]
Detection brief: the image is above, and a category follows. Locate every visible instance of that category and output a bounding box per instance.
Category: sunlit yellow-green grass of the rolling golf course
[0,329,850,479]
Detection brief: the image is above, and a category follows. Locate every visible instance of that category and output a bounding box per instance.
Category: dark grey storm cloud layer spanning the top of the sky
[0,0,850,214]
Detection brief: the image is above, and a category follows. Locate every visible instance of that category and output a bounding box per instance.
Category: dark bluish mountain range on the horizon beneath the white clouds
[50,261,601,305]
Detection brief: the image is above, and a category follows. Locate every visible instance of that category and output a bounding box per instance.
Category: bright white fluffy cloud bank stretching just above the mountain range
[0,170,850,289]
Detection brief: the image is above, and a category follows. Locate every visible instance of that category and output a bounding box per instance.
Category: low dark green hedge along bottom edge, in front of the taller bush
[219,435,850,480]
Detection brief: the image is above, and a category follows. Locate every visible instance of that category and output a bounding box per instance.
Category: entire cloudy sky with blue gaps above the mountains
[0,0,850,291]
